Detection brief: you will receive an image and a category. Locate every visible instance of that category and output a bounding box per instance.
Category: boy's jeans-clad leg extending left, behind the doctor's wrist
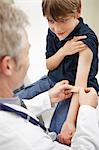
[15,76,54,99]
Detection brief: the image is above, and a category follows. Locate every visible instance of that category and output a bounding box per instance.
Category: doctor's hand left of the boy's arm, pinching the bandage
[48,80,72,104]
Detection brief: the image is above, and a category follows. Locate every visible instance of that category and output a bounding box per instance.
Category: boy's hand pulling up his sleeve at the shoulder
[60,36,87,57]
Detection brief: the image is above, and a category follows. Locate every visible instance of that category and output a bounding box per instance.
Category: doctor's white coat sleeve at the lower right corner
[71,105,99,150]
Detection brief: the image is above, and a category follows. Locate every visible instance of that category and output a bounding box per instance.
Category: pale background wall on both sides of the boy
[14,0,99,82]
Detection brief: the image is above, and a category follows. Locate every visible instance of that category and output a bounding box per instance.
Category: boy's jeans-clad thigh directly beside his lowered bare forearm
[50,99,70,133]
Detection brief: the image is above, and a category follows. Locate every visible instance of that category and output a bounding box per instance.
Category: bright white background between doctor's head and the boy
[14,0,47,82]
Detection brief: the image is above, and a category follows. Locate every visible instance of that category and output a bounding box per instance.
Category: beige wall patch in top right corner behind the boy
[82,0,99,38]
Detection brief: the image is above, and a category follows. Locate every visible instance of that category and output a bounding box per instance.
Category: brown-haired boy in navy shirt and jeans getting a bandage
[16,0,99,145]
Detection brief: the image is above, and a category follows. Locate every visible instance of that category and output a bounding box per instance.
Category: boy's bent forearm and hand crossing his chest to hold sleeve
[46,36,86,71]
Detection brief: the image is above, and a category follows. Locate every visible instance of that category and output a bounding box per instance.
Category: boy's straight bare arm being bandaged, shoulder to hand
[59,47,93,144]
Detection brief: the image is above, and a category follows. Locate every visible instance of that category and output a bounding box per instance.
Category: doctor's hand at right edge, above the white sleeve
[79,88,98,108]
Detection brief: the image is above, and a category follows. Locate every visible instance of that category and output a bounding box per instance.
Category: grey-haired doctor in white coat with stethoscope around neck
[0,1,99,150]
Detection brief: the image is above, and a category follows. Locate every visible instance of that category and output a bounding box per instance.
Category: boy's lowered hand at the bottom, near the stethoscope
[58,122,75,145]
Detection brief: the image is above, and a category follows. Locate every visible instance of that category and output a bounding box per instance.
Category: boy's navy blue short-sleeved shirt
[46,18,99,92]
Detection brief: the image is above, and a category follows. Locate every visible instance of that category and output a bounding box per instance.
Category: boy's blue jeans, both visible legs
[16,76,70,133]
